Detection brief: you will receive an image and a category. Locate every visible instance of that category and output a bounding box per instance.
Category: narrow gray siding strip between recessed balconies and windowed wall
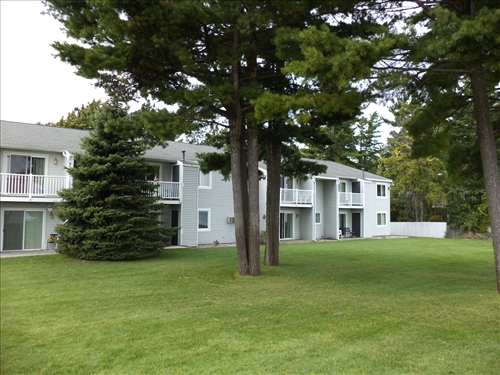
[180,164,198,246]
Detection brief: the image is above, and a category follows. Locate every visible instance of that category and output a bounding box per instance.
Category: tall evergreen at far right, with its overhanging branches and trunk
[380,0,500,293]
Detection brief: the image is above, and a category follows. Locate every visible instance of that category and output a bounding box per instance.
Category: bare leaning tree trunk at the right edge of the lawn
[472,62,500,293]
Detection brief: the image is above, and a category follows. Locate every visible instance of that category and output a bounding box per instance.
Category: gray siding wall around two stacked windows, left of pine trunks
[198,171,236,245]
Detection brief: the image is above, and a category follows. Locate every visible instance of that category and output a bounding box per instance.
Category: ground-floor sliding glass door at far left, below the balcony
[2,210,43,250]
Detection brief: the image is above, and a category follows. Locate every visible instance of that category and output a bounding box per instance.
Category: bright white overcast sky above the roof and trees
[0,0,390,142]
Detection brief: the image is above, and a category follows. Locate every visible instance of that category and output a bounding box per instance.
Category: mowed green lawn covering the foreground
[1,238,500,375]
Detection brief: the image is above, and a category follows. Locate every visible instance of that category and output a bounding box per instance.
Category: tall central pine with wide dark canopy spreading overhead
[48,0,384,275]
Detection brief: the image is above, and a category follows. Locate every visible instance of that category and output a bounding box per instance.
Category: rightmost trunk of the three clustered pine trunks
[264,140,281,266]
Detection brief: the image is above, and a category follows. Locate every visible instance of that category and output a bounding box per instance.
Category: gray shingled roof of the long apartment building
[0,121,391,182]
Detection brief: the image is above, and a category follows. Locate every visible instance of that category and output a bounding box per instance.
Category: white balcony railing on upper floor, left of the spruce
[0,173,69,198]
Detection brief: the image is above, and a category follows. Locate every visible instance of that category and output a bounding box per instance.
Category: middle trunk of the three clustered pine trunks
[248,123,260,276]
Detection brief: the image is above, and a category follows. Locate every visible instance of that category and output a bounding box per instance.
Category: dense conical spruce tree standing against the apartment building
[56,105,175,260]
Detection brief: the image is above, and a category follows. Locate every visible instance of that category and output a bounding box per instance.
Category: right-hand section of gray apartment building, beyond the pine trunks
[260,160,392,241]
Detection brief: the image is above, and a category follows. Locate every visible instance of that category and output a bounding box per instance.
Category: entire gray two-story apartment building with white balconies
[0,121,391,251]
